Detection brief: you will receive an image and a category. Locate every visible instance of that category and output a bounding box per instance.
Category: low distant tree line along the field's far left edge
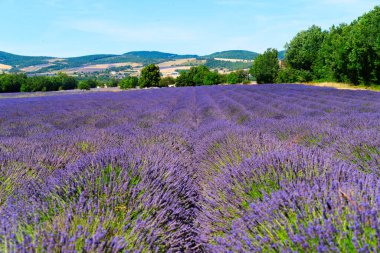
[0,64,250,92]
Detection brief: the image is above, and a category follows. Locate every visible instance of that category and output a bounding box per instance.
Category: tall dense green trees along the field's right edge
[250,6,380,85]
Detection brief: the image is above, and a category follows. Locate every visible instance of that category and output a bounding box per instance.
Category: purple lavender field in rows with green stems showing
[0,85,380,252]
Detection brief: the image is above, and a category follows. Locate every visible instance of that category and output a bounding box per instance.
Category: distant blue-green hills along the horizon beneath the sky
[0,50,284,72]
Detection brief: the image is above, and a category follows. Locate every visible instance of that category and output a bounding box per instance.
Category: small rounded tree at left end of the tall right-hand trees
[250,49,280,84]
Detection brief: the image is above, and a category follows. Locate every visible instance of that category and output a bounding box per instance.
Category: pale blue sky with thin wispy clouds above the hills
[0,0,380,57]
